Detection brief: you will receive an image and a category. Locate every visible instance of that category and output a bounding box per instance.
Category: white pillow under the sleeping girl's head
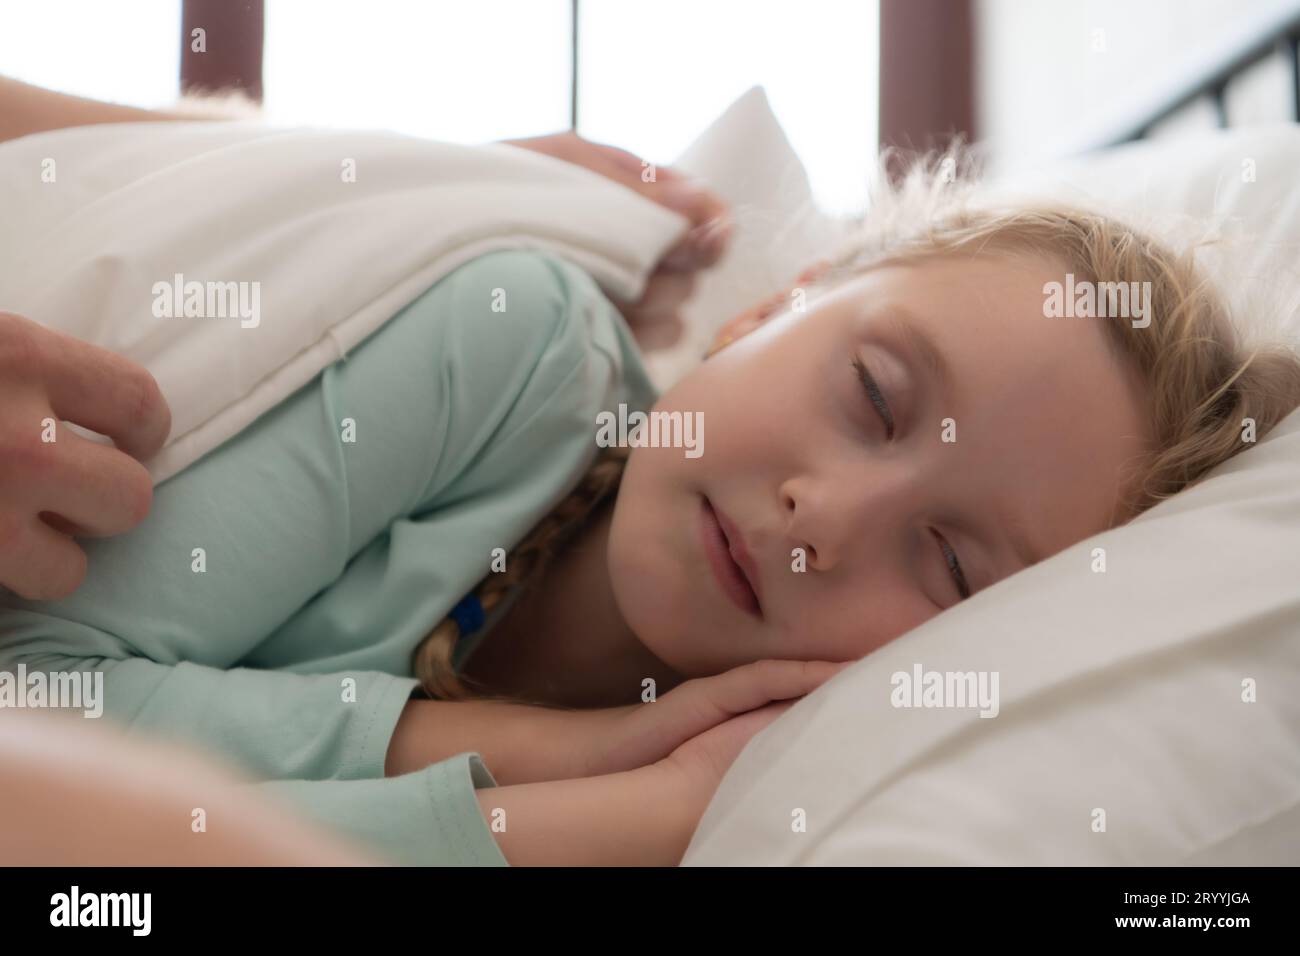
[683,103,1300,865]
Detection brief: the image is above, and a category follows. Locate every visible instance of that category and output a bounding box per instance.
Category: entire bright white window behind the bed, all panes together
[0,0,879,209]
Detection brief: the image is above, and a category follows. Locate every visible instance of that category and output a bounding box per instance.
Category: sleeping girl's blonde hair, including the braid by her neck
[415,146,1300,700]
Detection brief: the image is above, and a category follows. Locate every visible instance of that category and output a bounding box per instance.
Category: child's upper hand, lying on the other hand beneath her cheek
[579,659,853,786]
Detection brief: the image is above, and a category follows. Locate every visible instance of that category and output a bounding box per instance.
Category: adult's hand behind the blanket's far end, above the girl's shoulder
[503,131,732,351]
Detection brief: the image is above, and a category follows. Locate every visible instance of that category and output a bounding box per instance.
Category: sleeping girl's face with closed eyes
[608,256,1145,676]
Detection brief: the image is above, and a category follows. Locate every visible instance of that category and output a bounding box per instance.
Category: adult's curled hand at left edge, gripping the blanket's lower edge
[0,312,172,601]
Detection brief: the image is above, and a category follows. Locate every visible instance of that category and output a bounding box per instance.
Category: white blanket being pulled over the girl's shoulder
[0,122,686,481]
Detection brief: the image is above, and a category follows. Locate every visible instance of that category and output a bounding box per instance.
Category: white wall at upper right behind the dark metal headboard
[975,0,1300,168]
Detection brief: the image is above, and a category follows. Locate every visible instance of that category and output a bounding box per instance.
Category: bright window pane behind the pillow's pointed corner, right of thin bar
[579,0,879,211]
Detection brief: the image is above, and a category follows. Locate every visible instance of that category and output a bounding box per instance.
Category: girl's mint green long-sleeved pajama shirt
[0,250,655,865]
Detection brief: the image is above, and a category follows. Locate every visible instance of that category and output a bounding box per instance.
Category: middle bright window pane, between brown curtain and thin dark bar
[263,0,571,143]
